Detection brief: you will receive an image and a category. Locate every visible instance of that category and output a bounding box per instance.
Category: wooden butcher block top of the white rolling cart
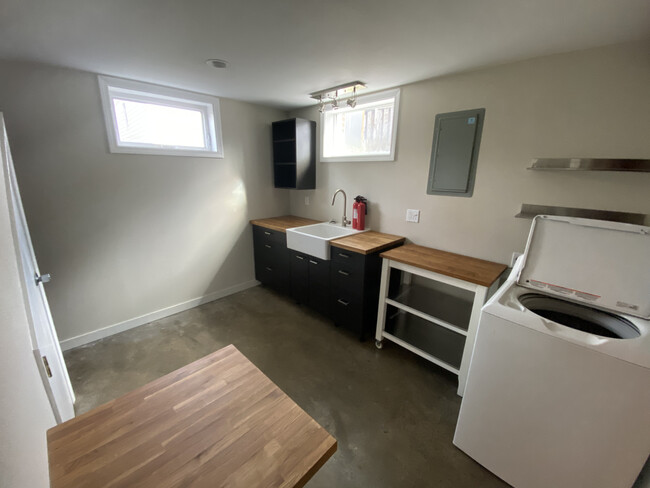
[380,244,507,287]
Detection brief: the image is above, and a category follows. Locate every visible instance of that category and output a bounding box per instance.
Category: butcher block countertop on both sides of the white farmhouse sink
[250,215,406,254]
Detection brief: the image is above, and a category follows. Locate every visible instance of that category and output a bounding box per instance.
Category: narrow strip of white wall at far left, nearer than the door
[0,113,55,488]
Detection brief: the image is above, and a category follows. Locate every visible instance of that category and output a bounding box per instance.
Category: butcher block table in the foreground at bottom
[47,345,336,488]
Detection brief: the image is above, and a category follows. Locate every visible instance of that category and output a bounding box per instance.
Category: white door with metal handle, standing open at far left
[0,113,74,423]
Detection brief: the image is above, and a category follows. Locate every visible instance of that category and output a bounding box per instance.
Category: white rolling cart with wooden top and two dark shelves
[375,244,506,396]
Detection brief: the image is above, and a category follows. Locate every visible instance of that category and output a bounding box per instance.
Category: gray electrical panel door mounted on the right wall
[427,109,484,196]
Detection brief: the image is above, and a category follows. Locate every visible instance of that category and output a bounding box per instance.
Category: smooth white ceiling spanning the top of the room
[0,0,650,109]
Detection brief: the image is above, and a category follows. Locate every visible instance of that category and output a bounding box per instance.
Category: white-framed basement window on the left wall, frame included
[99,76,223,158]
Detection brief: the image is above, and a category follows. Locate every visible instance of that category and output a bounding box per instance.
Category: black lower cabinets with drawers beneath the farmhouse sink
[253,225,401,340]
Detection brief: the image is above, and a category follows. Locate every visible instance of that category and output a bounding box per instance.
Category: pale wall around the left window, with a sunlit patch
[0,61,289,347]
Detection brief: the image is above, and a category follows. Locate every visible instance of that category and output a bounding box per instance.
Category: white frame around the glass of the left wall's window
[98,75,224,159]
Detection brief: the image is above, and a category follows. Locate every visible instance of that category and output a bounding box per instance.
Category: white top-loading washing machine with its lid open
[454,216,650,488]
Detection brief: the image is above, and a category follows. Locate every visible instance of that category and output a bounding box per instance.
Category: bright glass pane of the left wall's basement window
[113,98,206,149]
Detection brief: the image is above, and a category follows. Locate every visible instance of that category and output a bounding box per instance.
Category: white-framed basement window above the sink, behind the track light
[320,89,400,161]
